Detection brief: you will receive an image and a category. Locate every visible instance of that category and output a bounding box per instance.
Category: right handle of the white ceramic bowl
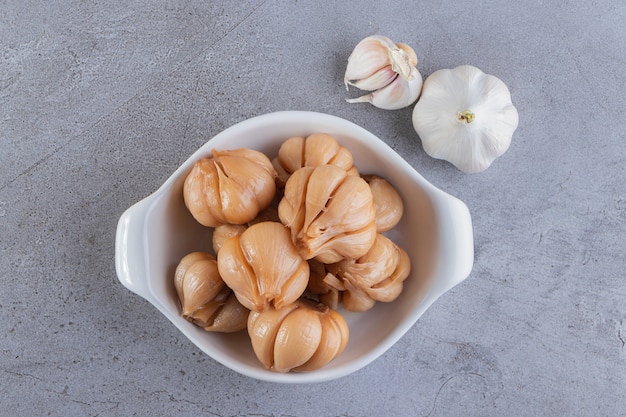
[439,194,474,294]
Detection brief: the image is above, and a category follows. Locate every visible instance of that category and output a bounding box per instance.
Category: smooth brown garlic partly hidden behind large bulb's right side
[363,175,404,233]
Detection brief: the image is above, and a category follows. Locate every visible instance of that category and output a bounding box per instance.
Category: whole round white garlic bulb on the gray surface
[413,65,519,173]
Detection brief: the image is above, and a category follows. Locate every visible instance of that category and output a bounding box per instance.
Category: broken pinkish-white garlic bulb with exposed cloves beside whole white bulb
[344,35,423,110]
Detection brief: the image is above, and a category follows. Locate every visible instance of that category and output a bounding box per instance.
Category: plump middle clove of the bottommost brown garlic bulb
[274,308,322,372]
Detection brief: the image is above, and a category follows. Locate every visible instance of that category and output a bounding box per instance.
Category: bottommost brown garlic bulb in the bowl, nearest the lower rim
[248,300,350,372]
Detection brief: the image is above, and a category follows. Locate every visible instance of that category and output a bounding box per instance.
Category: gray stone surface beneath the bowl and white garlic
[0,0,626,417]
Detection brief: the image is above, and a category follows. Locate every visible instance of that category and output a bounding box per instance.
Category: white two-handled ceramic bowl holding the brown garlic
[115,111,474,383]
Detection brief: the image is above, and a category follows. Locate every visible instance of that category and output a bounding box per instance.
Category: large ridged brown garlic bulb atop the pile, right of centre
[278,165,376,263]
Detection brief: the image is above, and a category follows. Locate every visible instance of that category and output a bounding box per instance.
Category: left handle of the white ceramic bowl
[115,199,150,298]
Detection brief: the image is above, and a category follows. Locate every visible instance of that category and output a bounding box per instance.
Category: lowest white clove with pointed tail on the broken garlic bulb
[346,65,422,110]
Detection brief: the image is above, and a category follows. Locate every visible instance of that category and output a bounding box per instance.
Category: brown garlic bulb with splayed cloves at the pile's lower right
[324,234,411,311]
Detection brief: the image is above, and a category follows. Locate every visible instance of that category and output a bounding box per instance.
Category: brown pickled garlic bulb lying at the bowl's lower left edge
[174,252,249,333]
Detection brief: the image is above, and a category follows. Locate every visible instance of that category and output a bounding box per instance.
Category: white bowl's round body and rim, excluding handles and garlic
[139,112,438,382]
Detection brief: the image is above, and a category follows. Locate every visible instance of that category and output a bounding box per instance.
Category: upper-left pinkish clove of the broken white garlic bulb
[344,35,395,88]
